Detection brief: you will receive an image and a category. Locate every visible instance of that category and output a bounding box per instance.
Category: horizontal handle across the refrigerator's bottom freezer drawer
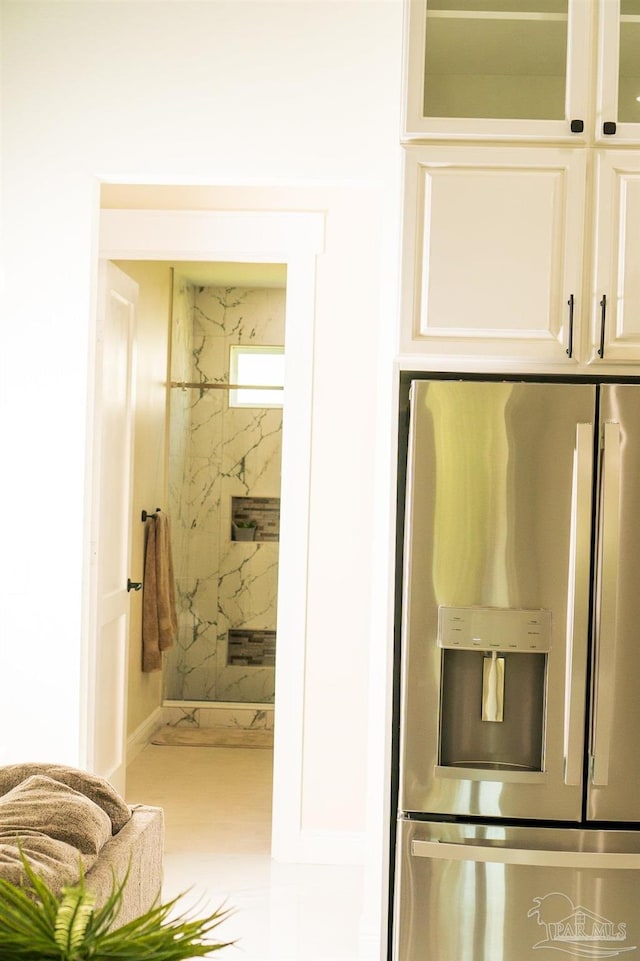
[411,840,640,871]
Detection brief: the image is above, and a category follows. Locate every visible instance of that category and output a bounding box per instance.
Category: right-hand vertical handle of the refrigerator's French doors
[591,421,621,785]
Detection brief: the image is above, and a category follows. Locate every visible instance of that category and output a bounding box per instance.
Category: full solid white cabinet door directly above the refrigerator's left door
[402,147,585,362]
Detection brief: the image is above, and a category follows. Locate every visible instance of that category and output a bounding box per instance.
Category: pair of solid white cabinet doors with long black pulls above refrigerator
[399,144,640,370]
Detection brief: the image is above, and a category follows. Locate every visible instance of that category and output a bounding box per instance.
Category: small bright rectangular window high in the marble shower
[229,344,284,407]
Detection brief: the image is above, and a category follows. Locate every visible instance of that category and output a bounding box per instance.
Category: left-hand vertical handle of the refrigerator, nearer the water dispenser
[564,424,593,785]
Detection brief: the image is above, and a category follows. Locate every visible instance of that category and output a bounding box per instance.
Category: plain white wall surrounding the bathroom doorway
[0,0,402,884]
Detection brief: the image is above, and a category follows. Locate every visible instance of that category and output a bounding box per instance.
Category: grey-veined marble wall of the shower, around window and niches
[165,275,285,703]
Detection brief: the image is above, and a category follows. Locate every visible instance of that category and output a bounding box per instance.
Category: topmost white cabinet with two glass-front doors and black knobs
[404,0,640,144]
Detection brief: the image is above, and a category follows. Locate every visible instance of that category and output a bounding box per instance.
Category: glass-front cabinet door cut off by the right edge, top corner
[595,0,640,146]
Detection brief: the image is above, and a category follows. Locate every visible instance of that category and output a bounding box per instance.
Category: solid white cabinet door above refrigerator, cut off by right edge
[591,151,640,363]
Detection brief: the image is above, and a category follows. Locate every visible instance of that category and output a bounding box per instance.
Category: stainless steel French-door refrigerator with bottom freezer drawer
[391,379,640,961]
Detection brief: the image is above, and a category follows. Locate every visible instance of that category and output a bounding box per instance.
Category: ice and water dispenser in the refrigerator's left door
[438,607,551,771]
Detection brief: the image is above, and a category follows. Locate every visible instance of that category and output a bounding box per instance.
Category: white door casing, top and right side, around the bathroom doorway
[95,209,325,862]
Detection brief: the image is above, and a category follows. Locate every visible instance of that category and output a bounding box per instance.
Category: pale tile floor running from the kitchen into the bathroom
[127,745,372,961]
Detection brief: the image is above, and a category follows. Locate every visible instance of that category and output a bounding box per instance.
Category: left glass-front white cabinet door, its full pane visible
[405,0,592,140]
